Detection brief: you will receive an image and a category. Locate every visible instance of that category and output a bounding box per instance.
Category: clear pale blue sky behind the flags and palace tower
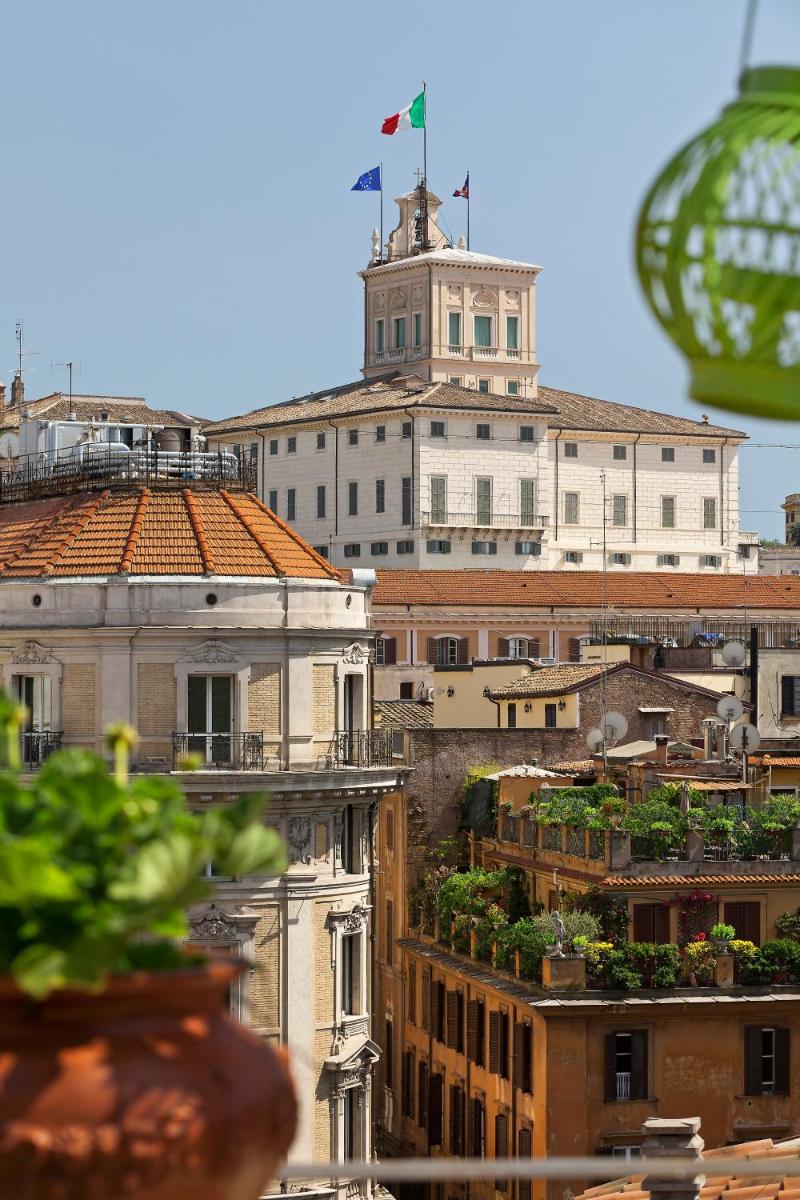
[0,0,800,538]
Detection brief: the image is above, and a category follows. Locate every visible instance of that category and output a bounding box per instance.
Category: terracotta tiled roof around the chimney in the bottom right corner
[577,1138,800,1200]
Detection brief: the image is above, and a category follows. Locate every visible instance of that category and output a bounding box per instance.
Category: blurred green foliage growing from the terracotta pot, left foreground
[0,697,285,997]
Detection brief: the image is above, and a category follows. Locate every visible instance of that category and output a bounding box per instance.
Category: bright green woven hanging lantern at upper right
[636,67,800,420]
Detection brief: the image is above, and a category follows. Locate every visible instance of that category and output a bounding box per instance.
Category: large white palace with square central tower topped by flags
[204,190,758,572]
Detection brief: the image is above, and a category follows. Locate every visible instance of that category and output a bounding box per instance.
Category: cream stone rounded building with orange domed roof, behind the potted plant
[0,485,403,1200]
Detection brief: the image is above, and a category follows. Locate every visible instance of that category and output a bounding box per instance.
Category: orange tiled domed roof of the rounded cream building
[0,487,338,581]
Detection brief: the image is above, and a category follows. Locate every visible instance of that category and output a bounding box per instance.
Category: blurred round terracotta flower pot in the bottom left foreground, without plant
[0,962,296,1200]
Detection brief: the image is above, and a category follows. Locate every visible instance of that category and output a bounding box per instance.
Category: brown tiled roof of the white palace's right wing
[537,385,747,438]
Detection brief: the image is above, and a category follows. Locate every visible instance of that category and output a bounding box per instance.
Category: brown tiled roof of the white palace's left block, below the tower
[204,372,555,436]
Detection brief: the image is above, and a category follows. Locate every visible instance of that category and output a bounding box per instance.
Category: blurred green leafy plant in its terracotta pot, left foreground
[0,698,296,1200]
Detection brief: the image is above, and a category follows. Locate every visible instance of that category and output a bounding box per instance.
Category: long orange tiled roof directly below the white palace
[373,570,800,609]
